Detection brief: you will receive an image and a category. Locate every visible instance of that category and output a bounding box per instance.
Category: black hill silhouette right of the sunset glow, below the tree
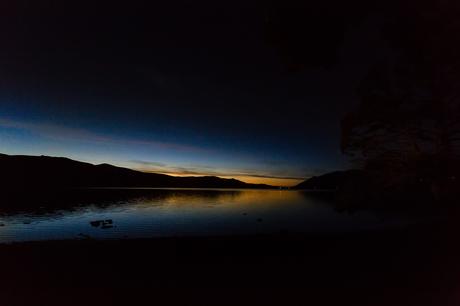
[293,168,460,215]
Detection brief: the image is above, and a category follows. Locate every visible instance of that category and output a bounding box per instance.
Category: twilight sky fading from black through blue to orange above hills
[0,0,385,186]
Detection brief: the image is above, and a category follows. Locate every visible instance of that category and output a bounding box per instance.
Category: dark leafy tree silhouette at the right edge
[341,1,460,196]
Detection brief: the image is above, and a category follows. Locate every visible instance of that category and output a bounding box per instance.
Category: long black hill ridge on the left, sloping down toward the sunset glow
[0,154,274,190]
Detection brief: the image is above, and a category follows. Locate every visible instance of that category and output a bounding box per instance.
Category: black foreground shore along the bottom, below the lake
[0,222,460,306]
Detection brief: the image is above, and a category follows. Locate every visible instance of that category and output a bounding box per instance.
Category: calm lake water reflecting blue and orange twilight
[0,189,416,242]
